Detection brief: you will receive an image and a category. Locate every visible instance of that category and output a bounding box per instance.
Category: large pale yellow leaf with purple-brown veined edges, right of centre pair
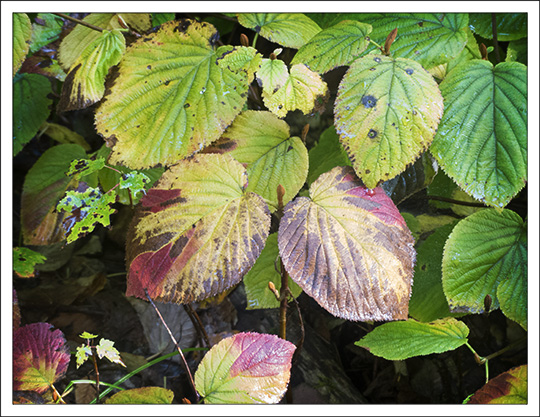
[278,167,415,321]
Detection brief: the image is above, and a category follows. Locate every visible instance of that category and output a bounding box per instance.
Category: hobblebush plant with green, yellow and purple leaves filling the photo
[13,13,527,403]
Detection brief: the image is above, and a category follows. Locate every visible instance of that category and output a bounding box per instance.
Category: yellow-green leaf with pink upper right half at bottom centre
[195,333,296,404]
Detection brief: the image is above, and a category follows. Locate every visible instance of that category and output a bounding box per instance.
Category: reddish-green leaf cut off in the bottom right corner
[467,365,528,404]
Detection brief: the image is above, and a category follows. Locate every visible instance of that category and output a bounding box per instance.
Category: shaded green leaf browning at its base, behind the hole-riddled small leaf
[21,144,86,245]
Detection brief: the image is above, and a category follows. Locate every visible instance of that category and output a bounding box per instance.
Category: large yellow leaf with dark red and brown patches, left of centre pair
[126,154,270,303]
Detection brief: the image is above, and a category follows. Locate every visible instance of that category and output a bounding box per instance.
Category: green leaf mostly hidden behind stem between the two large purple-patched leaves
[243,233,302,310]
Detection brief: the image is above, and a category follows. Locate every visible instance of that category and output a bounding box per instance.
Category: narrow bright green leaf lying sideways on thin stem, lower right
[355,317,469,361]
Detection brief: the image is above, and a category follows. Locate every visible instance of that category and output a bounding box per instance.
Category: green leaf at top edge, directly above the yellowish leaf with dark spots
[361,13,469,68]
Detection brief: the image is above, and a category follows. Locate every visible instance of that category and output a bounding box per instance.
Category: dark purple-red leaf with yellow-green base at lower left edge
[13,323,69,393]
